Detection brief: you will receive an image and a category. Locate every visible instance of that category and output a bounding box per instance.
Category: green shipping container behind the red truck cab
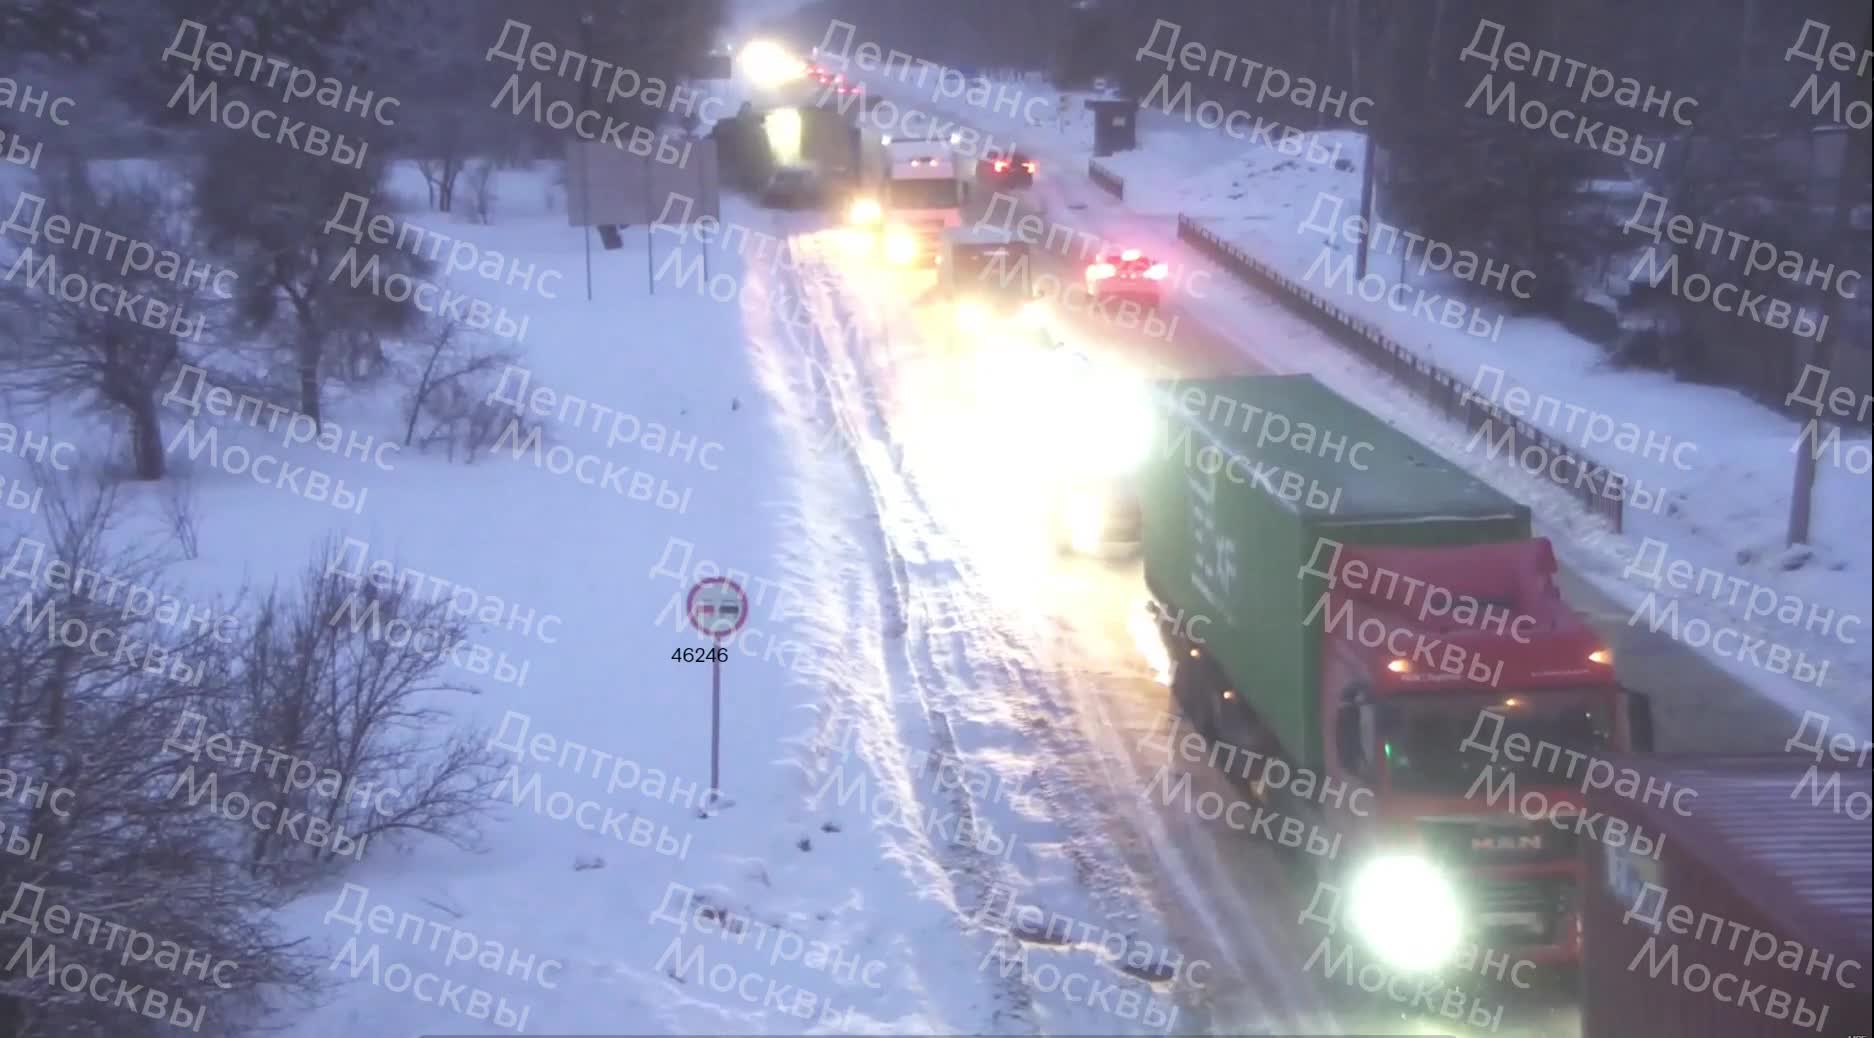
[1139,375,1531,768]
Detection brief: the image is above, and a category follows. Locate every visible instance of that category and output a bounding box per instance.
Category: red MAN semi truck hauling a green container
[1139,375,1651,976]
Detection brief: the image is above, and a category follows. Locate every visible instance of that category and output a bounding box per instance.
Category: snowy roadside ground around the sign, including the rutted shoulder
[6,157,1259,1038]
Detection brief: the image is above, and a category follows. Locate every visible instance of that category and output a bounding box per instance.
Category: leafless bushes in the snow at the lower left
[0,472,497,1038]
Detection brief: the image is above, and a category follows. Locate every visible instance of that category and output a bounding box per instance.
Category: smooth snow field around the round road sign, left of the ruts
[234,169,1011,1036]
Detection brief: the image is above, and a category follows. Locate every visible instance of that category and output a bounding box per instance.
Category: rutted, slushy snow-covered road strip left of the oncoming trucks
[772,199,1626,1038]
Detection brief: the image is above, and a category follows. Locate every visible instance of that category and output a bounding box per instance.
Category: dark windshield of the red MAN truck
[1379,691,1614,796]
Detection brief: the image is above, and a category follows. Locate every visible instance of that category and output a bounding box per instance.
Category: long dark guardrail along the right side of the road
[1176,212,1627,530]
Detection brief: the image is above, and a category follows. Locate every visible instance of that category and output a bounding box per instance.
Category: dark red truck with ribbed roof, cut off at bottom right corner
[1580,753,1874,1038]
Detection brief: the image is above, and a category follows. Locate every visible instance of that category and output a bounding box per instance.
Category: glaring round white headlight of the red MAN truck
[1347,854,1464,974]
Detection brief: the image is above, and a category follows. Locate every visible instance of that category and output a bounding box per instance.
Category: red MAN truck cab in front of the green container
[1319,538,1651,965]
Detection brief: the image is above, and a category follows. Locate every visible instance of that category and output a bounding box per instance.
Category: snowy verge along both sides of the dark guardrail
[843,75,1874,738]
